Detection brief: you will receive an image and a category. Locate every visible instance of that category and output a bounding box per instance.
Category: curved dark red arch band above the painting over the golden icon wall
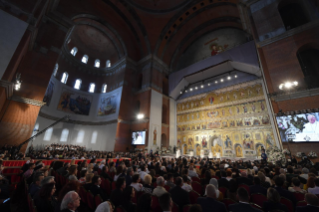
[154,0,238,56]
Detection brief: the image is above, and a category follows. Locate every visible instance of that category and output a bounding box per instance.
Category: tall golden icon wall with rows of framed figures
[177,81,276,157]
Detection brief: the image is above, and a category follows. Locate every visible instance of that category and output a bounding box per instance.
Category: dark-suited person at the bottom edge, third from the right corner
[229,188,262,212]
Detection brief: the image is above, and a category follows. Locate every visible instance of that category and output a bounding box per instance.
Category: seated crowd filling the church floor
[0,150,319,212]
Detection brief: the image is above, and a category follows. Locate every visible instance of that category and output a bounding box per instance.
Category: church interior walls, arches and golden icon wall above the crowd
[0,0,319,158]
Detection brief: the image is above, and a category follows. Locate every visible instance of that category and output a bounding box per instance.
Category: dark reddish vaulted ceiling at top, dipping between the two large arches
[52,0,244,71]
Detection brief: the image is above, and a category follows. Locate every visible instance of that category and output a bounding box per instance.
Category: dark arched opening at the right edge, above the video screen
[297,47,319,88]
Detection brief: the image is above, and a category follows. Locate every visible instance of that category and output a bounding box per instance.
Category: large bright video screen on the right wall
[276,112,319,142]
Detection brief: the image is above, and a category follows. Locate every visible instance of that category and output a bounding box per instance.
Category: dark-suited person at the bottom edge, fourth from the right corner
[197,184,227,212]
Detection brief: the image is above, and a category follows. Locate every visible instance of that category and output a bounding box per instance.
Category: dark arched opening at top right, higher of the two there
[278,0,308,30]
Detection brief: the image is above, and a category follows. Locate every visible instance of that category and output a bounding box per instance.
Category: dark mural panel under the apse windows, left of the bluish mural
[58,89,92,115]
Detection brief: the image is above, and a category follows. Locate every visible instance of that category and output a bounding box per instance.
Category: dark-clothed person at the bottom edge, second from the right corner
[263,188,289,212]
